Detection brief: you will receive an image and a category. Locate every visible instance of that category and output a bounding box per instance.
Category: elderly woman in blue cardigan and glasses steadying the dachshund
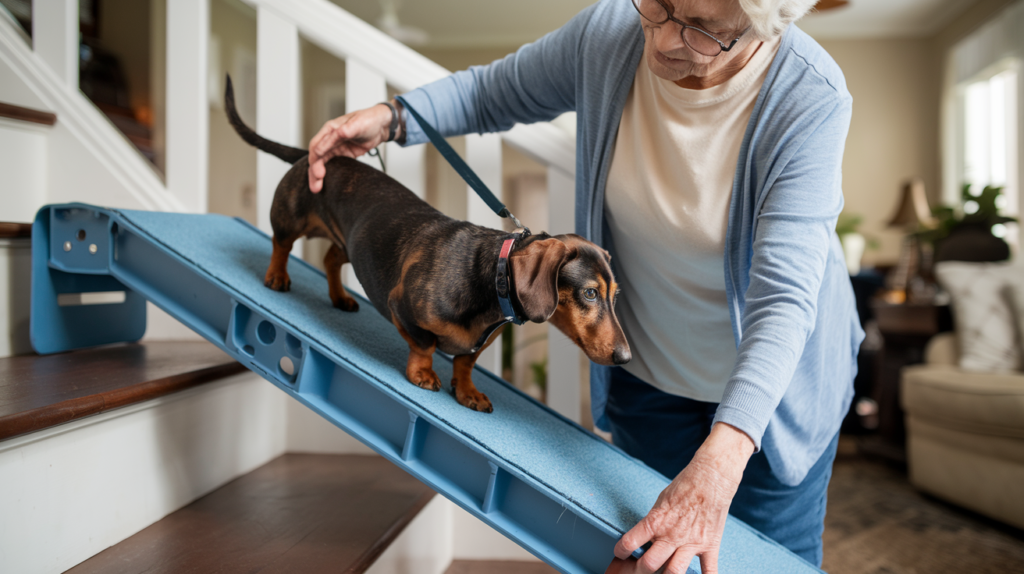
[309,0,863,573]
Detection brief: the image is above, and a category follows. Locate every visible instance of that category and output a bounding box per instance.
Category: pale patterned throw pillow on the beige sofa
[935,261,1024,372]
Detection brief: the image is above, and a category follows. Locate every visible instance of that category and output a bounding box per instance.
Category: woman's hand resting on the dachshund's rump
[309,102,398,193]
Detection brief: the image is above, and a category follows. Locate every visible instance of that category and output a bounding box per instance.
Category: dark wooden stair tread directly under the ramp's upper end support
[0,341,246,440]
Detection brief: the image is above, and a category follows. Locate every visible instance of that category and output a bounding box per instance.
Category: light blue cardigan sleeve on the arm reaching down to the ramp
[715,94,852,449]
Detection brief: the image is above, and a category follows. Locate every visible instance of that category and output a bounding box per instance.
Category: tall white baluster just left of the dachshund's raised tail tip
[166,0,210,213]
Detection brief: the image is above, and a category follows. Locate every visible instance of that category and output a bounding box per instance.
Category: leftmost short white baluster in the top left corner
[32,0,79,90]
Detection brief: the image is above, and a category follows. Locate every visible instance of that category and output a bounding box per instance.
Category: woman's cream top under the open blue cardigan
[605,38,779,402]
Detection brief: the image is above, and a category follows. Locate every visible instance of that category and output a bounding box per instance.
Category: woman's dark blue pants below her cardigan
[605,367,839,567]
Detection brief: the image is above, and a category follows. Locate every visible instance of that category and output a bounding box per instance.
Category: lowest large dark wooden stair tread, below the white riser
[68,454,434,574]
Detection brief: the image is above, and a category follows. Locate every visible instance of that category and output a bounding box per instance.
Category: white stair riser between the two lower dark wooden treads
[0,372,287,574]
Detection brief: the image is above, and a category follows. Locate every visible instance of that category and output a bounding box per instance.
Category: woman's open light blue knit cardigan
[403,0,863,485]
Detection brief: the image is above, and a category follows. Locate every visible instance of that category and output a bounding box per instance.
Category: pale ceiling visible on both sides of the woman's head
[331,0,977,48]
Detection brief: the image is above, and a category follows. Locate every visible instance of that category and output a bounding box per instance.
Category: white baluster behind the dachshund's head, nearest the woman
[548,166,581,423]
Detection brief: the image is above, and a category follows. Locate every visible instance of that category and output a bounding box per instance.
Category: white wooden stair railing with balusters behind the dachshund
[6,0,581,421]
